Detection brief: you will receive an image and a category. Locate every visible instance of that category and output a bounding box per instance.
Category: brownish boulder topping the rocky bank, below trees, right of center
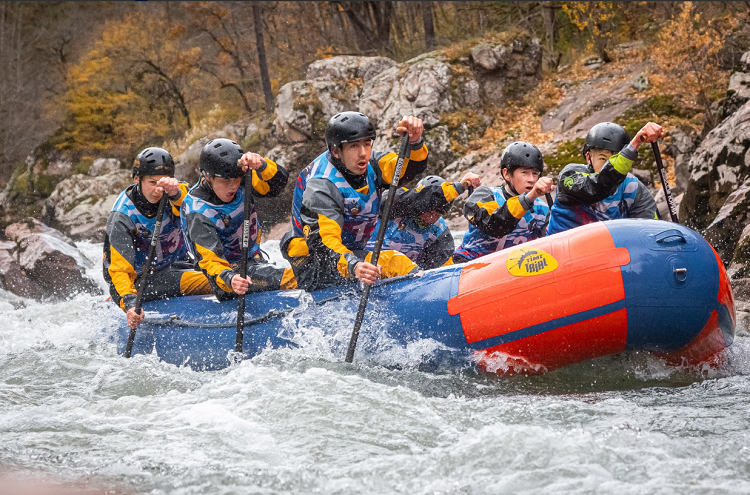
[471,38,542,106]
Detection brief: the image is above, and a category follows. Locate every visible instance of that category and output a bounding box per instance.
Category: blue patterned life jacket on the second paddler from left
[182,181,260,265]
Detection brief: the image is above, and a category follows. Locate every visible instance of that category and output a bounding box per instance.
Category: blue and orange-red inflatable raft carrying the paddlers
[118,220,735,373]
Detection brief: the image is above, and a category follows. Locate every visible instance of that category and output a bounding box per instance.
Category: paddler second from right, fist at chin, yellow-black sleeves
[453,141,555,263]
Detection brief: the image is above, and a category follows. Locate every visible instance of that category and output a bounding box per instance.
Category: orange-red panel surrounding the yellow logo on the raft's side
[448,223,630,373]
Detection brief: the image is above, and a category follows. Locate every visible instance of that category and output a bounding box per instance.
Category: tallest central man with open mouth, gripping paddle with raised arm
[281,112,427,290]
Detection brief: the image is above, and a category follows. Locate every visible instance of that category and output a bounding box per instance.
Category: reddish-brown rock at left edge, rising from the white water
[0,218,100,300]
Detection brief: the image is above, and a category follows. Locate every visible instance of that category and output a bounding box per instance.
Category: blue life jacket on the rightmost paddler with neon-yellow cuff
[547,173,639,235]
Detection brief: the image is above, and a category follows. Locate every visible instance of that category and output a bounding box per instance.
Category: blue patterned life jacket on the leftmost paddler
[112,185,188,274]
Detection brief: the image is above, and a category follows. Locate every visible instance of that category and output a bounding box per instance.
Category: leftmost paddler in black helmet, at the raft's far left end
[104,148,211,328]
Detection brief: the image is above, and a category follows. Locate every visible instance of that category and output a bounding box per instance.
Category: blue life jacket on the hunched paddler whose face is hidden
[367,217,448,263]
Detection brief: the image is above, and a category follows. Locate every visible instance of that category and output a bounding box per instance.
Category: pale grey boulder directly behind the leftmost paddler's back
[42,170,133,241]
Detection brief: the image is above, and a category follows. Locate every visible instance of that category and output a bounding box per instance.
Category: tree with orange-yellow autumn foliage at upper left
[56,13,200,156]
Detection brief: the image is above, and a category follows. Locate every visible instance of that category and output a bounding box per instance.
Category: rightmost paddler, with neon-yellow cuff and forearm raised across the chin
[547,122,664,234]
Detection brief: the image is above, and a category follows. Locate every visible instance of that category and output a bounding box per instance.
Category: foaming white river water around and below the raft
[0,242,750,495]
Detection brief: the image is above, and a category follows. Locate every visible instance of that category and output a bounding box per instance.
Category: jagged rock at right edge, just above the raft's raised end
[680,102,750,230]
